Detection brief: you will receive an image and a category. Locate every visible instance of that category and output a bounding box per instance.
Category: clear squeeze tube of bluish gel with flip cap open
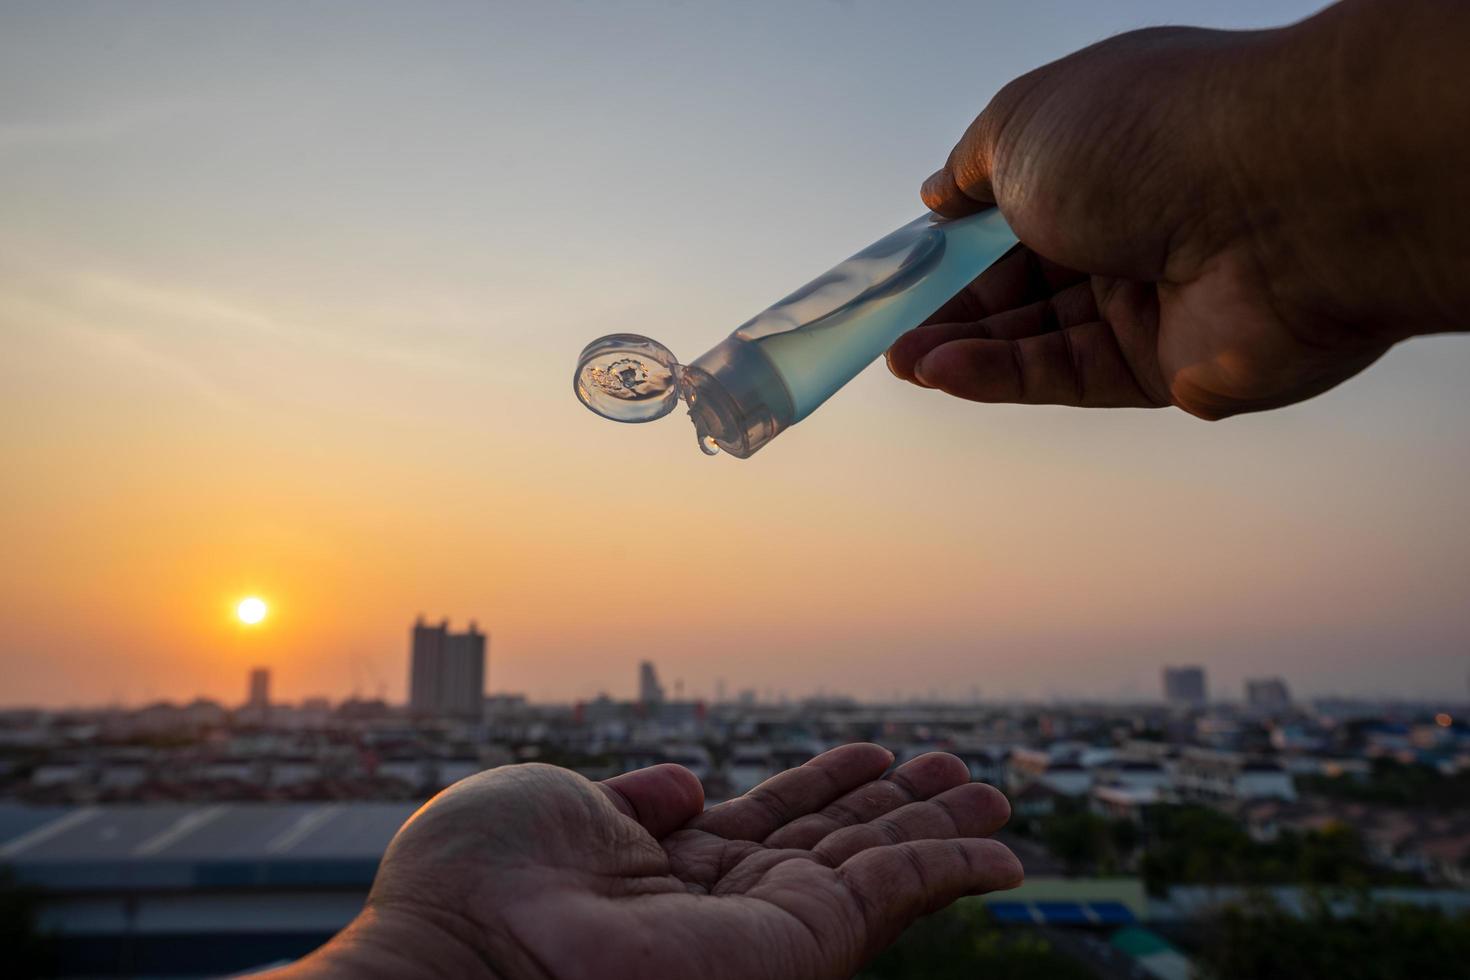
[573,207,1016,458]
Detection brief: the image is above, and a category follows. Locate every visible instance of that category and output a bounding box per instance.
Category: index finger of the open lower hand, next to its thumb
[691,742,894,840]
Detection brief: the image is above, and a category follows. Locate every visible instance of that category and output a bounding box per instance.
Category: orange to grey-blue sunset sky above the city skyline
[0,0,1470,704]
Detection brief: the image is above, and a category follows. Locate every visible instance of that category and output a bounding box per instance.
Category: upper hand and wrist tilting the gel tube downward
[888,0,1470,419]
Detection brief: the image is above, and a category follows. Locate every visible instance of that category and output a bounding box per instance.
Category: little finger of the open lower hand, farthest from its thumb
[836,837,1025,959]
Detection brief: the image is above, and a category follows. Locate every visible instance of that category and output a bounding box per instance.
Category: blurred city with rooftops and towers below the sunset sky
[0,619,1470,980]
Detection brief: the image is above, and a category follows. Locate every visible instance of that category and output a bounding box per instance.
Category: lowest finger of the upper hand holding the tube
[913,320,1167,408]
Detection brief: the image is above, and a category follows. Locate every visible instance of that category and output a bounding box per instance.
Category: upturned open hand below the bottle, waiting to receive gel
[286,745,1022,979]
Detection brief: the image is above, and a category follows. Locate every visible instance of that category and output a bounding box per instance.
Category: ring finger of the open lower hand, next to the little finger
[811,783,1010,865]
